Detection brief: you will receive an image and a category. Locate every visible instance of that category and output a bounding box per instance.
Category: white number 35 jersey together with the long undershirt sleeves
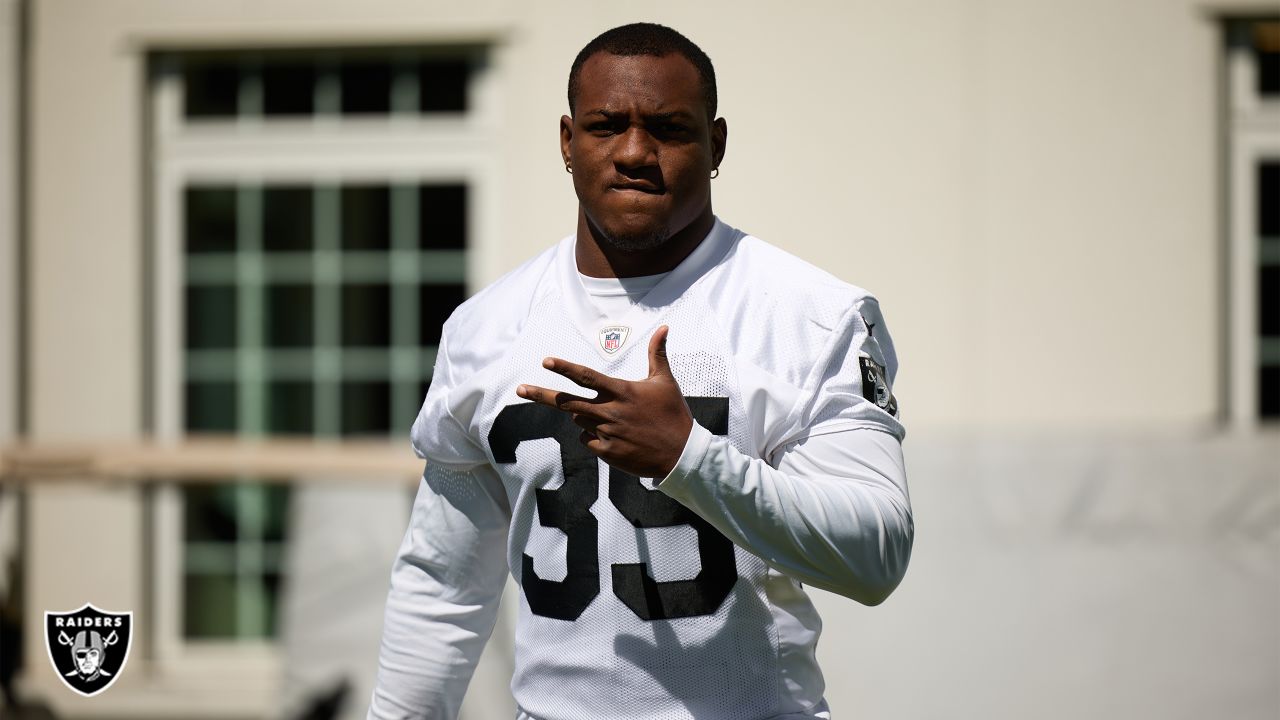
[370,220,911,720]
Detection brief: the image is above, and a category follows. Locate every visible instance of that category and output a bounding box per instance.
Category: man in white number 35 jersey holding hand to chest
[369,23,913,720]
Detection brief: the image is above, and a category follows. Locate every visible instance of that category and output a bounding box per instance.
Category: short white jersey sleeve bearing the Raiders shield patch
[780,296,906,446]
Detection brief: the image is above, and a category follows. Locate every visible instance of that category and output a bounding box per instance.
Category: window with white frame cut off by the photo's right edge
[1226,19,1280,427]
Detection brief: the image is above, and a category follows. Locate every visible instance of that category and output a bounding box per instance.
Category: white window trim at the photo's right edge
[1226,35,1280,432]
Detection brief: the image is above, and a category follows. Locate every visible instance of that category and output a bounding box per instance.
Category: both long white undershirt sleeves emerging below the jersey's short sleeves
[369,424,913,720]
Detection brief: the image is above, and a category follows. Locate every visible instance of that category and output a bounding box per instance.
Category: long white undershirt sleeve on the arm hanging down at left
[367,464,511,720]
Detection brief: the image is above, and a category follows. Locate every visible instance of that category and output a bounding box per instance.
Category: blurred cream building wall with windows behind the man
[0,0,1280,720]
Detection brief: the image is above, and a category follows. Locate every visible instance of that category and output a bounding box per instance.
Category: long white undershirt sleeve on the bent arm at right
[658,424,915,605]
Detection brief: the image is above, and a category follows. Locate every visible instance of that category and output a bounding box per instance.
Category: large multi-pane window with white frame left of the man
[150,47,493,656]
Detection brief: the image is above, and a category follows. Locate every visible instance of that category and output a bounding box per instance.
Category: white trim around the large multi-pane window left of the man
[147,44,500,681]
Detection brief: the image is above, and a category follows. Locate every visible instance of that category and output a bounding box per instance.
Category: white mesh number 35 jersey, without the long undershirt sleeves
[399,220,904,720]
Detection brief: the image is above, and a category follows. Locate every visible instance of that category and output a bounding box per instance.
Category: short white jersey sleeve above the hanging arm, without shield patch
[410,324,488,470]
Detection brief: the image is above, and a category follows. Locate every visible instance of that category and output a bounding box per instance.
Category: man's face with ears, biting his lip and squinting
[561,53,726,251]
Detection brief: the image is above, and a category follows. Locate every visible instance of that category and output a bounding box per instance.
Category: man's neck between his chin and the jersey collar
[575,209,716,278]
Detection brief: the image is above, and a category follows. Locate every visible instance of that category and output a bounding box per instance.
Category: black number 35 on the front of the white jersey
[489,397,737,620]
